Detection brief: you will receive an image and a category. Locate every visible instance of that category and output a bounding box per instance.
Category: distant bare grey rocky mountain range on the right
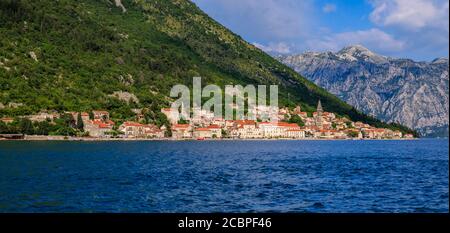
[278,45,449,137]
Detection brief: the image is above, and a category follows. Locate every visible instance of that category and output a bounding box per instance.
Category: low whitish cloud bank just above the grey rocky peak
[307,28,405,53]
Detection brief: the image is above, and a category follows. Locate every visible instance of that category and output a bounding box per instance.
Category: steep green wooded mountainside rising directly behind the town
[0,0,412,135]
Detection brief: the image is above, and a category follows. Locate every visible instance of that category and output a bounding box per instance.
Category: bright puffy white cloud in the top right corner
[370,0,449,31]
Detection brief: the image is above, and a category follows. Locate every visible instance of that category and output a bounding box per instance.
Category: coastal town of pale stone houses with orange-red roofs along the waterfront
[0,100,414,140]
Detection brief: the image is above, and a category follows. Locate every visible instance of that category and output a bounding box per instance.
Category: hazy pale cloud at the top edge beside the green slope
[194,0,315,41]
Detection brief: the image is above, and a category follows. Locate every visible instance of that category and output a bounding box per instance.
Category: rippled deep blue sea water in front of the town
[0,139,449,213]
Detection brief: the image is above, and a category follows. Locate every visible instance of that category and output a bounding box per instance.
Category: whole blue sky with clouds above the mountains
[192,0,449,61]
